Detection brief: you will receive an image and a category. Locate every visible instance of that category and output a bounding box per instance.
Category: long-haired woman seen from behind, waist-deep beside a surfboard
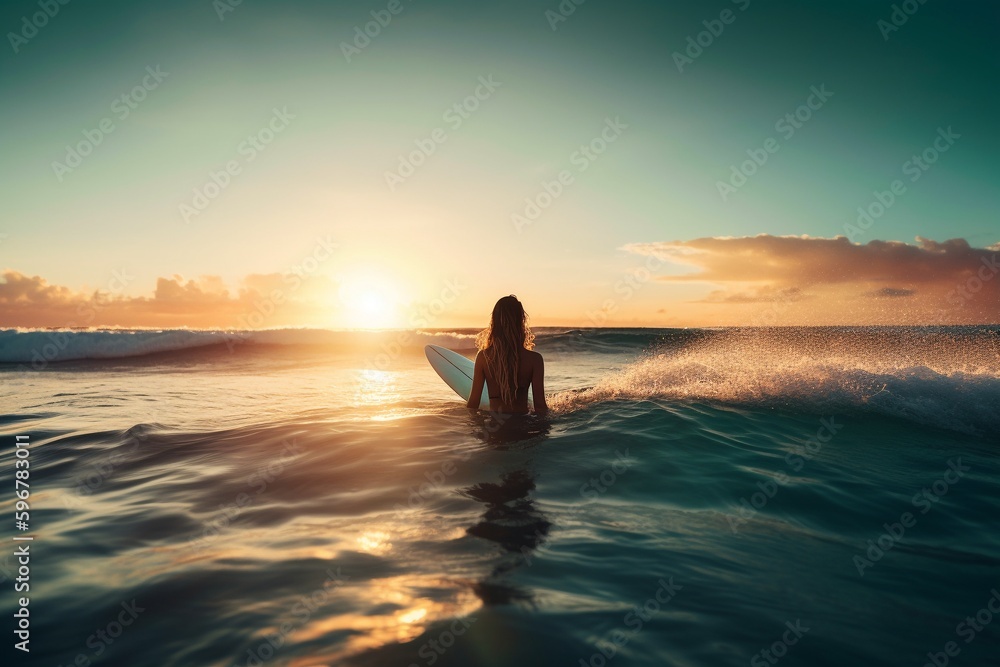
[467,294,549,415]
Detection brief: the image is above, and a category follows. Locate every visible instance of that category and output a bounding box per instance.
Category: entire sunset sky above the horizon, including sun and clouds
[0,0,1000,328]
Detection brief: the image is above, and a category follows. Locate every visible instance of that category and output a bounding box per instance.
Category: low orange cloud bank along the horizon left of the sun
[0,269,336,329]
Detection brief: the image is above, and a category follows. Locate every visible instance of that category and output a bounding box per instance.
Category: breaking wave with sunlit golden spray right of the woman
[549,327,1000,436]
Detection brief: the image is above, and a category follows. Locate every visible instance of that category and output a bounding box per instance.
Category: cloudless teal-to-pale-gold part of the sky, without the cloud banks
[0,0,1000,325]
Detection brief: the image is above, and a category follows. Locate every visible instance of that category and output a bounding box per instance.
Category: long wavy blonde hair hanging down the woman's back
[476,294,535,405]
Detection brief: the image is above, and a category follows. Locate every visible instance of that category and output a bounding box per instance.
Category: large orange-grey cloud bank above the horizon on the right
[623,234,1000,324]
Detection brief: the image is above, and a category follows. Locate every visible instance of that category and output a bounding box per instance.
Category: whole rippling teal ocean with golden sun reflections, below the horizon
[0,326,1000,667]
